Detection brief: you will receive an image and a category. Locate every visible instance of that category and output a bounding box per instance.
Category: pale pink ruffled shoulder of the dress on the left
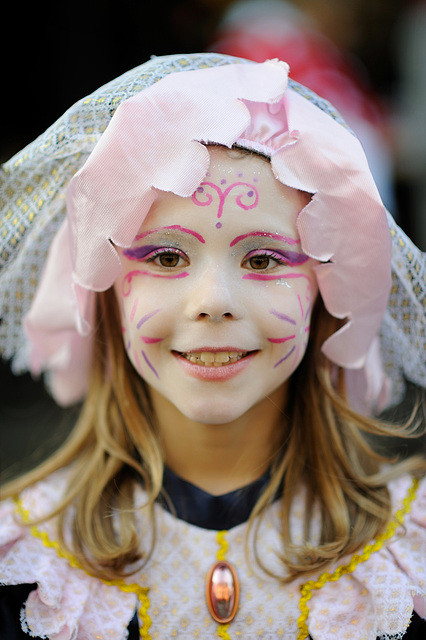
[0,472,137,640]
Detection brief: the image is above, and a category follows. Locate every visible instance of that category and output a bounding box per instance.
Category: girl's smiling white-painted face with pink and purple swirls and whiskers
[114,147,317,424]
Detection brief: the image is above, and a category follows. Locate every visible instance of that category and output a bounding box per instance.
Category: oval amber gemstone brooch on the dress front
[206,561,240,624]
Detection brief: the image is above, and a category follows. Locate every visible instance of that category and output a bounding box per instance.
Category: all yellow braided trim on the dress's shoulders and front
[15,478,419,640]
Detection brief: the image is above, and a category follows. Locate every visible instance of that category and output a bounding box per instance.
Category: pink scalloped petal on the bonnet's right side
[238,89,391,368]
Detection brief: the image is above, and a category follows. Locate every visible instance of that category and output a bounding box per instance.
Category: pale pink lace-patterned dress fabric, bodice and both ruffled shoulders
[0,472,426,640]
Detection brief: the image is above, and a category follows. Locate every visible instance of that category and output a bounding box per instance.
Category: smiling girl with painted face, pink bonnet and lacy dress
[0,54,426,640]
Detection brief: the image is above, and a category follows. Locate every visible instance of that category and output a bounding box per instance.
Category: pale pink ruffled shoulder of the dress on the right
[301,477,426,640]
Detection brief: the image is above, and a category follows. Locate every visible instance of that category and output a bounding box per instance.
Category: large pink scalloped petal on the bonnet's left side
[67,62,288,291]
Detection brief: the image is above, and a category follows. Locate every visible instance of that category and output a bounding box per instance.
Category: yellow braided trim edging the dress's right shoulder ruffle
[297,478,419,640]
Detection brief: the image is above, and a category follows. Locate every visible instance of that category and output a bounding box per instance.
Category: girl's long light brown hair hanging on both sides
[4,290,426,580]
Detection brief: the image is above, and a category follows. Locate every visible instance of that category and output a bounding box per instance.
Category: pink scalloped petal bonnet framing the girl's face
[8,54,398,404]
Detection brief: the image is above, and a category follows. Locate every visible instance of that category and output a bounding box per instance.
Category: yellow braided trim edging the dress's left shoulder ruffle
[15,499,152,640]
